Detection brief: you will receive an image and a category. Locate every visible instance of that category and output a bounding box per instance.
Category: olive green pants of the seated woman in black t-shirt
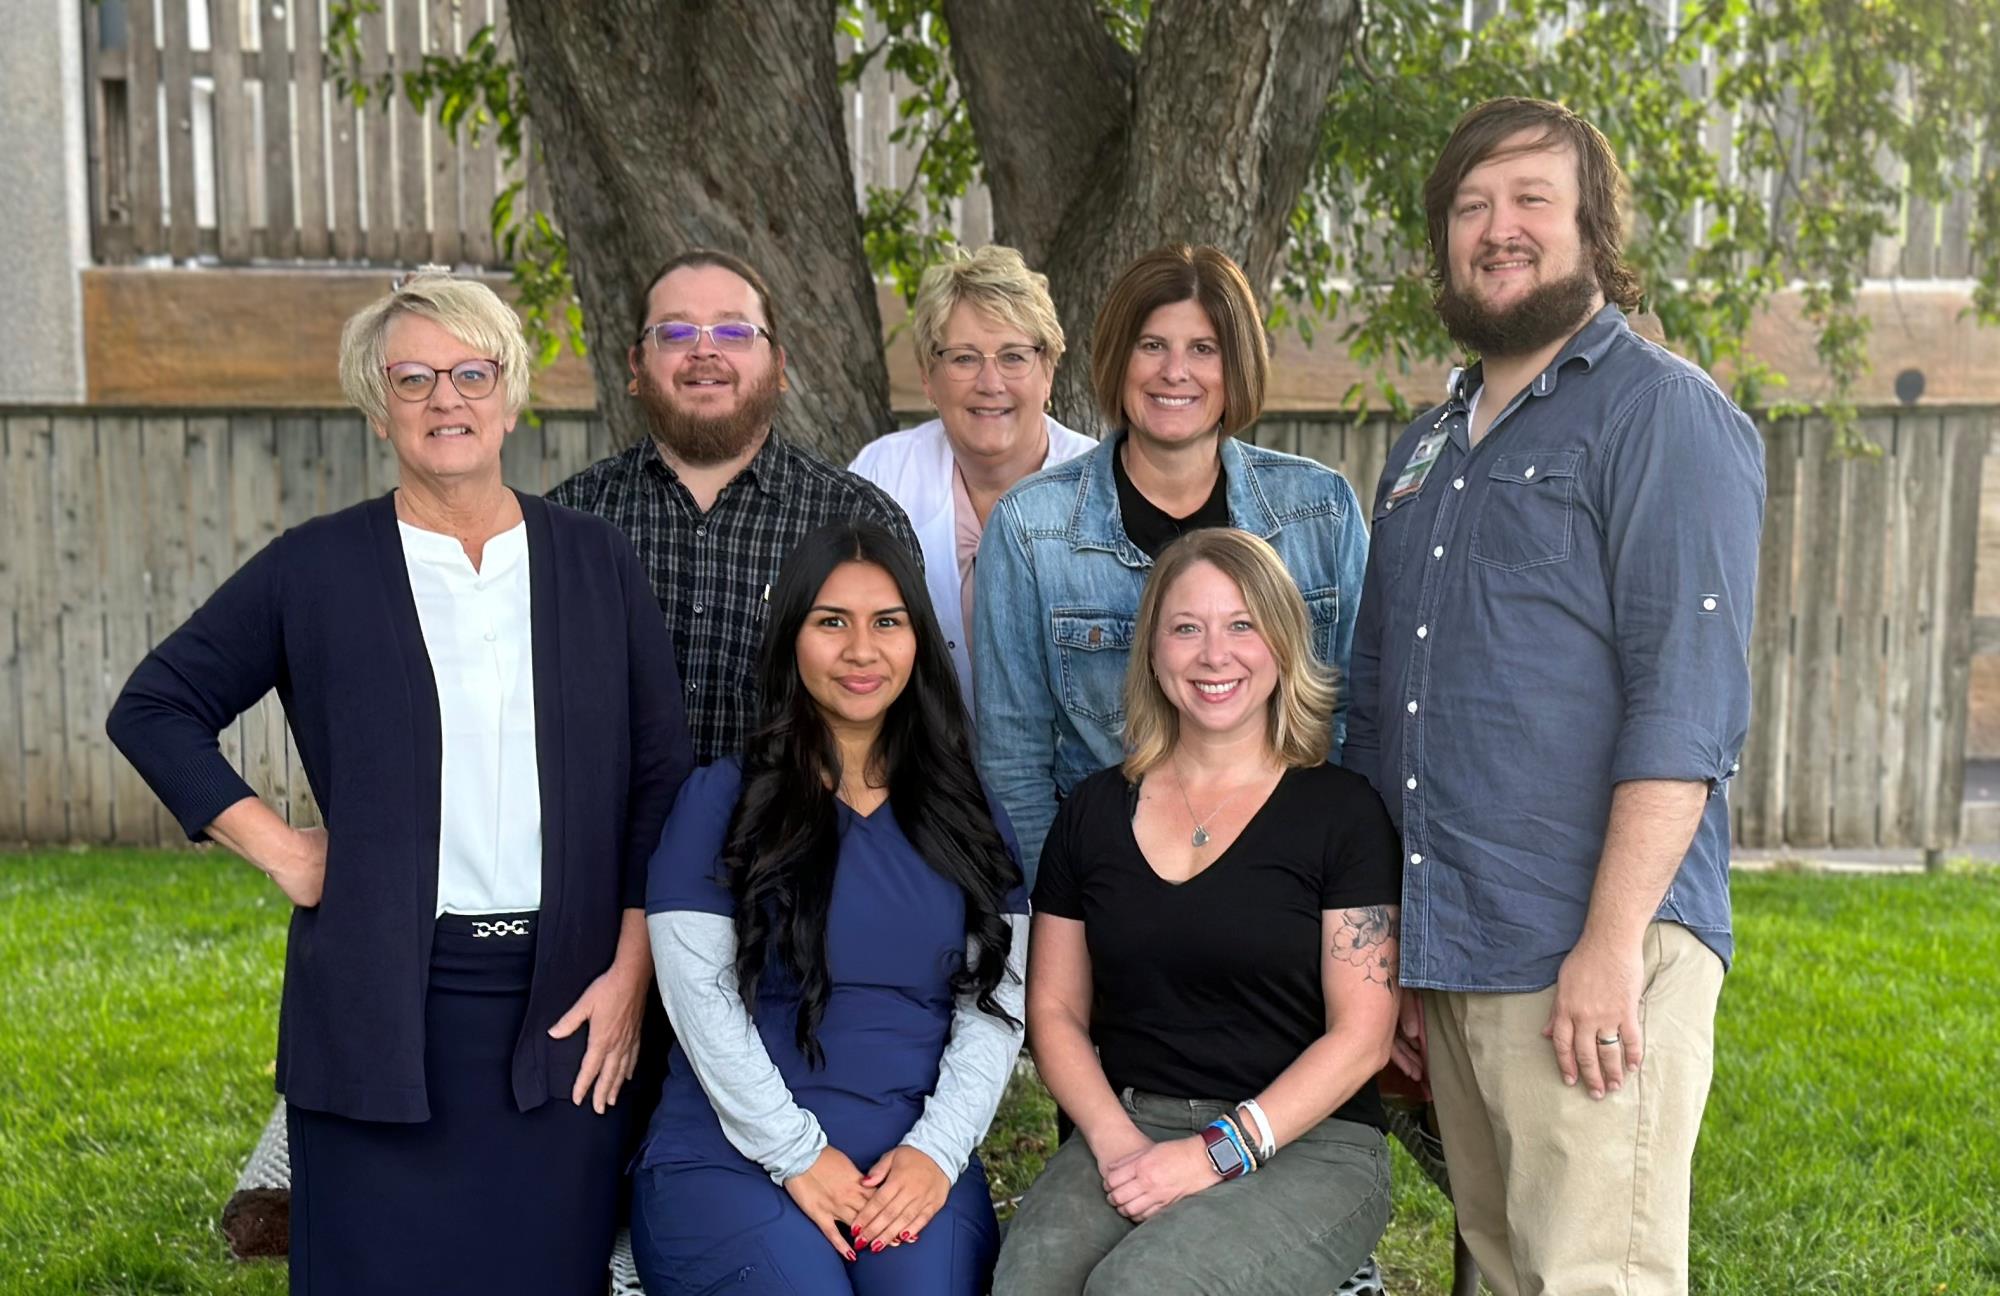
[994,1090,1390,1296]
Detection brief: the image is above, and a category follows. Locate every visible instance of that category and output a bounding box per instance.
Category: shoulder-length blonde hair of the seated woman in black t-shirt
[1124,526,1336,782]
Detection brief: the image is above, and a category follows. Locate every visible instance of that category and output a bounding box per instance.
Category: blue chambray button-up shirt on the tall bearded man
[1342,306,1764,992]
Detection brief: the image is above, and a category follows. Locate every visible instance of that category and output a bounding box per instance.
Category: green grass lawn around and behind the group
[0,852,2000,1296]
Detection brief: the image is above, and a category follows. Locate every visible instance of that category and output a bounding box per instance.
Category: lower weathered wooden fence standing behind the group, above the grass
[0,410,2000,848]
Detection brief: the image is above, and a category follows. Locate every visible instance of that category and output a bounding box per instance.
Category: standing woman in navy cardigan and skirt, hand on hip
[108,270,692,1296]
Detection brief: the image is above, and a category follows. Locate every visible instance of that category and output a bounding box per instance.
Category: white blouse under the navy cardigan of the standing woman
[396,520,542,914]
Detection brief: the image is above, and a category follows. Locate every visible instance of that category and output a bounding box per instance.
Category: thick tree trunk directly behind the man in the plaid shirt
[508,0,890,462]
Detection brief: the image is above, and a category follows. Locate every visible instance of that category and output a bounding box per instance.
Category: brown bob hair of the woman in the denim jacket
[1090,244,1270,436]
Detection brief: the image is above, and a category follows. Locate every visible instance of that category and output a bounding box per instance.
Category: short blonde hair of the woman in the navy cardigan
[340,266,530,426]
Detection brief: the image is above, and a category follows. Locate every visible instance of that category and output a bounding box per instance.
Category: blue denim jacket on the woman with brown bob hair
[972,432,1368,886]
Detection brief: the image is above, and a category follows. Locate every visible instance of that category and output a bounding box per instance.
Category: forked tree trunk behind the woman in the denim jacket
[944,0,1356,430]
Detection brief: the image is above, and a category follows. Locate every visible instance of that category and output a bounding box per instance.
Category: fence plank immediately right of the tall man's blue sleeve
[1730,418,1802,848]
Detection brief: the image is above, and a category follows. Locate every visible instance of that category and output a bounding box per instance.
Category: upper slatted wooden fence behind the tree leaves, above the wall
[82,0,2000,280]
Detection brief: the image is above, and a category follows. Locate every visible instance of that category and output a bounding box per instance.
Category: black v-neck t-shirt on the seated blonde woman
[1034,766,1402,1128]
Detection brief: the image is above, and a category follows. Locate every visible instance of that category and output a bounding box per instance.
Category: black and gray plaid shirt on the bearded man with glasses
[548,432,924,764]
